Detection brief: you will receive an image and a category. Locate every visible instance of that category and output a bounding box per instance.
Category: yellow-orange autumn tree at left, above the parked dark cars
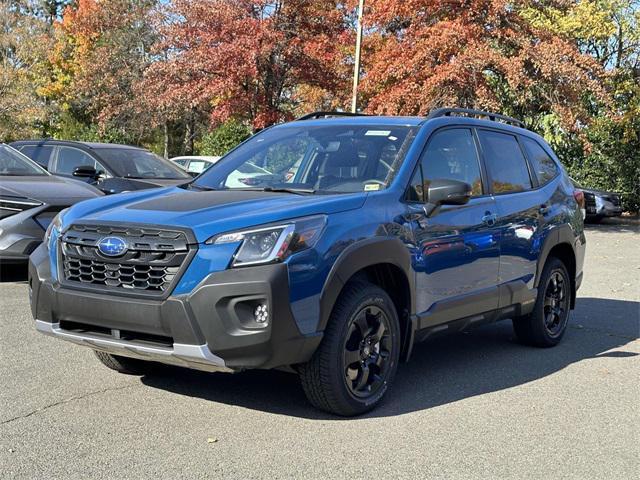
[47,0,156,141]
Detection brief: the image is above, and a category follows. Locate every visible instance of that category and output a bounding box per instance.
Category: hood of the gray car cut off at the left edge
[0,175,102,206]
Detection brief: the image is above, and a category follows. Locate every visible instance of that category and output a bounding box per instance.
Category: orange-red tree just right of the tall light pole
[362,0,608,129]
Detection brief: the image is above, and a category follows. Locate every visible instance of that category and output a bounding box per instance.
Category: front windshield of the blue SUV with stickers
[194,122,416,193]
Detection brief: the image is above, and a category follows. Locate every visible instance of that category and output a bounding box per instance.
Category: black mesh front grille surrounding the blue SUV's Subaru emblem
[61,225,191,295]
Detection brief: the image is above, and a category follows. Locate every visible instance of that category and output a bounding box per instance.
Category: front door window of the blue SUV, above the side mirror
[407,128,482,202]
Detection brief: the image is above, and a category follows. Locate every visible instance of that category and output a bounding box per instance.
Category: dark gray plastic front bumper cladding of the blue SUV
[29,247,321,369]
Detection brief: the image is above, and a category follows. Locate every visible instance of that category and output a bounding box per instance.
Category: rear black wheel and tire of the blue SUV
[513,257,572,348]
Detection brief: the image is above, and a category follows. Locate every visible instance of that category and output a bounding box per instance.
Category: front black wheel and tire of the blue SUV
[298,282,400,416]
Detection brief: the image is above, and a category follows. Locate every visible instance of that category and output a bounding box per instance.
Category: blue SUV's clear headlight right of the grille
[206,215,327,267]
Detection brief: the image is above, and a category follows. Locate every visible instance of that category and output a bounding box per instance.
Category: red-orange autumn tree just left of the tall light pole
[145,0,351,128]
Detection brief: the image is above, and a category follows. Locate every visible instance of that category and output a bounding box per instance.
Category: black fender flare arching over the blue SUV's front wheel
[318,237,415,332]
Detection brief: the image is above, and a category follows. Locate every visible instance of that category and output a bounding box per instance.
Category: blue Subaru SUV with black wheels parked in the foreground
[29,109,585,415]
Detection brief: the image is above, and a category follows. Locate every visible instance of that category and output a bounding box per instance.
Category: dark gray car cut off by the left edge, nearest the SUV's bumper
[0,144,103,263]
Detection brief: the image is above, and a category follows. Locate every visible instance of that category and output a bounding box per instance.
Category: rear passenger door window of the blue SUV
[478,130,531,193]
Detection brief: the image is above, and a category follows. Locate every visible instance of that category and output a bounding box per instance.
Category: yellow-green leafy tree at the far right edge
[521,0,640,211]
